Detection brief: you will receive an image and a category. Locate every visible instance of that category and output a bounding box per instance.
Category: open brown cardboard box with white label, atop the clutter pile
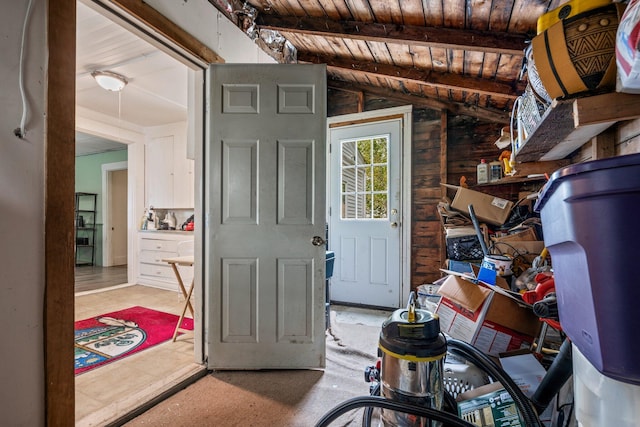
[442,184,513,229]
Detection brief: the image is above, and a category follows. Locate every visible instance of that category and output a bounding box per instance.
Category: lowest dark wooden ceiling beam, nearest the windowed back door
[327,79,510,124]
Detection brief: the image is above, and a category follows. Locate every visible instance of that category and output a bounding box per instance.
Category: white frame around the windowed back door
[326,105,413,306]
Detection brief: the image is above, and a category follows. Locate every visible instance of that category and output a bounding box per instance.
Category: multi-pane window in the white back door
[340,135,389,220]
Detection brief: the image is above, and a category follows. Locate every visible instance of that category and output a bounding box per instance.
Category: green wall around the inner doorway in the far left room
[76,149,127,265]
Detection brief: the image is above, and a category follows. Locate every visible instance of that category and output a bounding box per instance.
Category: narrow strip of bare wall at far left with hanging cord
[0,0,46,426]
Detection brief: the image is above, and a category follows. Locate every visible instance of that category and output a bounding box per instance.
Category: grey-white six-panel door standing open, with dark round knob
[203,64,326,369]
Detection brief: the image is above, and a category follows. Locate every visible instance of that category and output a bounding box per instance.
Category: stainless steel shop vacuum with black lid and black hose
[316,292,544,427]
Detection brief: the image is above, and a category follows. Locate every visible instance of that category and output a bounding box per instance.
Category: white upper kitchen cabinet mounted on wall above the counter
[145,123,194,209]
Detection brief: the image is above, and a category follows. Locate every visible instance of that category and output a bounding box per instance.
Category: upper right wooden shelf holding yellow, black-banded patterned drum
[512,0,640,162]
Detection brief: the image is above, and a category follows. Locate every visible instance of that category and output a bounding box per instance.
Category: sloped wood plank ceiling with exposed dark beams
[209,0,565,123]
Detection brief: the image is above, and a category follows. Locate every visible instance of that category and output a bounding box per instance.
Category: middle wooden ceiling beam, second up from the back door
[298,51,525,99]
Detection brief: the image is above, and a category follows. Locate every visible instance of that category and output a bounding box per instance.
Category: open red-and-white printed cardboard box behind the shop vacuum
[436,274,540,357]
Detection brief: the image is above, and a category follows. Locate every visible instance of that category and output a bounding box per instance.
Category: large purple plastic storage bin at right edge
[535,154,640,384]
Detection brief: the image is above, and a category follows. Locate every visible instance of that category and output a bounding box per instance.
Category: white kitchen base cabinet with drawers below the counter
[137,231,194,291]
